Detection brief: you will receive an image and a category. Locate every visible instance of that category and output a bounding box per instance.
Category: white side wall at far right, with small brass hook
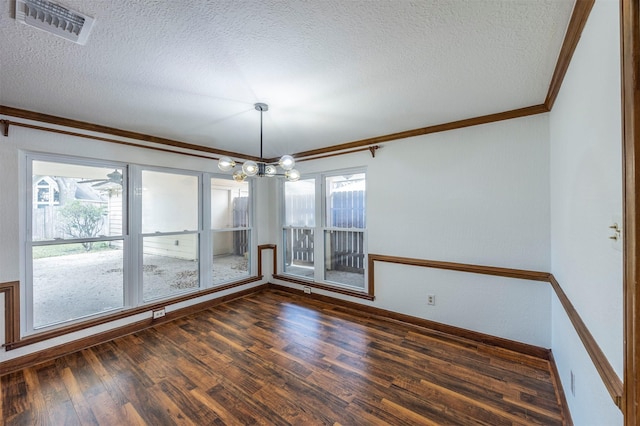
[550,0,623,425]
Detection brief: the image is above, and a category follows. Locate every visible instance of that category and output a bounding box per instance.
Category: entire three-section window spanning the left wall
[22,154,252,335]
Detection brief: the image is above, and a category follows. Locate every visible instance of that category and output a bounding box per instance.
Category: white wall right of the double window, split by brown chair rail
[274,114,551,348]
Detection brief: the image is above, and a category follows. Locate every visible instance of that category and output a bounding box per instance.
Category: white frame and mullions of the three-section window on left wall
[18,150,260,336]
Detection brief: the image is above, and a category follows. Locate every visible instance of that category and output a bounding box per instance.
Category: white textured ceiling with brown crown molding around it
[0,0,573,157]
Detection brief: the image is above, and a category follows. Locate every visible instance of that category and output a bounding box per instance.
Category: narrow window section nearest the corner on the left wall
[211,178,251,285]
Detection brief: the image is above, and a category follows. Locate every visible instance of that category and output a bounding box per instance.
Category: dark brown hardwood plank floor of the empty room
[0,290,564,426]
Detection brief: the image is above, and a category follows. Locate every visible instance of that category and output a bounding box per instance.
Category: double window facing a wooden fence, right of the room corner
[283,170,366,290]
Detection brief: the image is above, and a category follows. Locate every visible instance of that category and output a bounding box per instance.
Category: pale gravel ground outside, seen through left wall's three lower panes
[33,250,248,328]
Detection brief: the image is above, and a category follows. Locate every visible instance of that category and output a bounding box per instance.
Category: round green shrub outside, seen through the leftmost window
[60,200,107,251]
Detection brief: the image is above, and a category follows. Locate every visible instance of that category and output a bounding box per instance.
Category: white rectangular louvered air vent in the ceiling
[16,0,95,44]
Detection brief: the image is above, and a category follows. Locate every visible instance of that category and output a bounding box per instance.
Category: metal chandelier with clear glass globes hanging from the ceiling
[218,102,300,182]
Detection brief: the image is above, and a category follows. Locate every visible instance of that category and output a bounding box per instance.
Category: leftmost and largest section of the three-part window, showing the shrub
[26,160,126,330]
